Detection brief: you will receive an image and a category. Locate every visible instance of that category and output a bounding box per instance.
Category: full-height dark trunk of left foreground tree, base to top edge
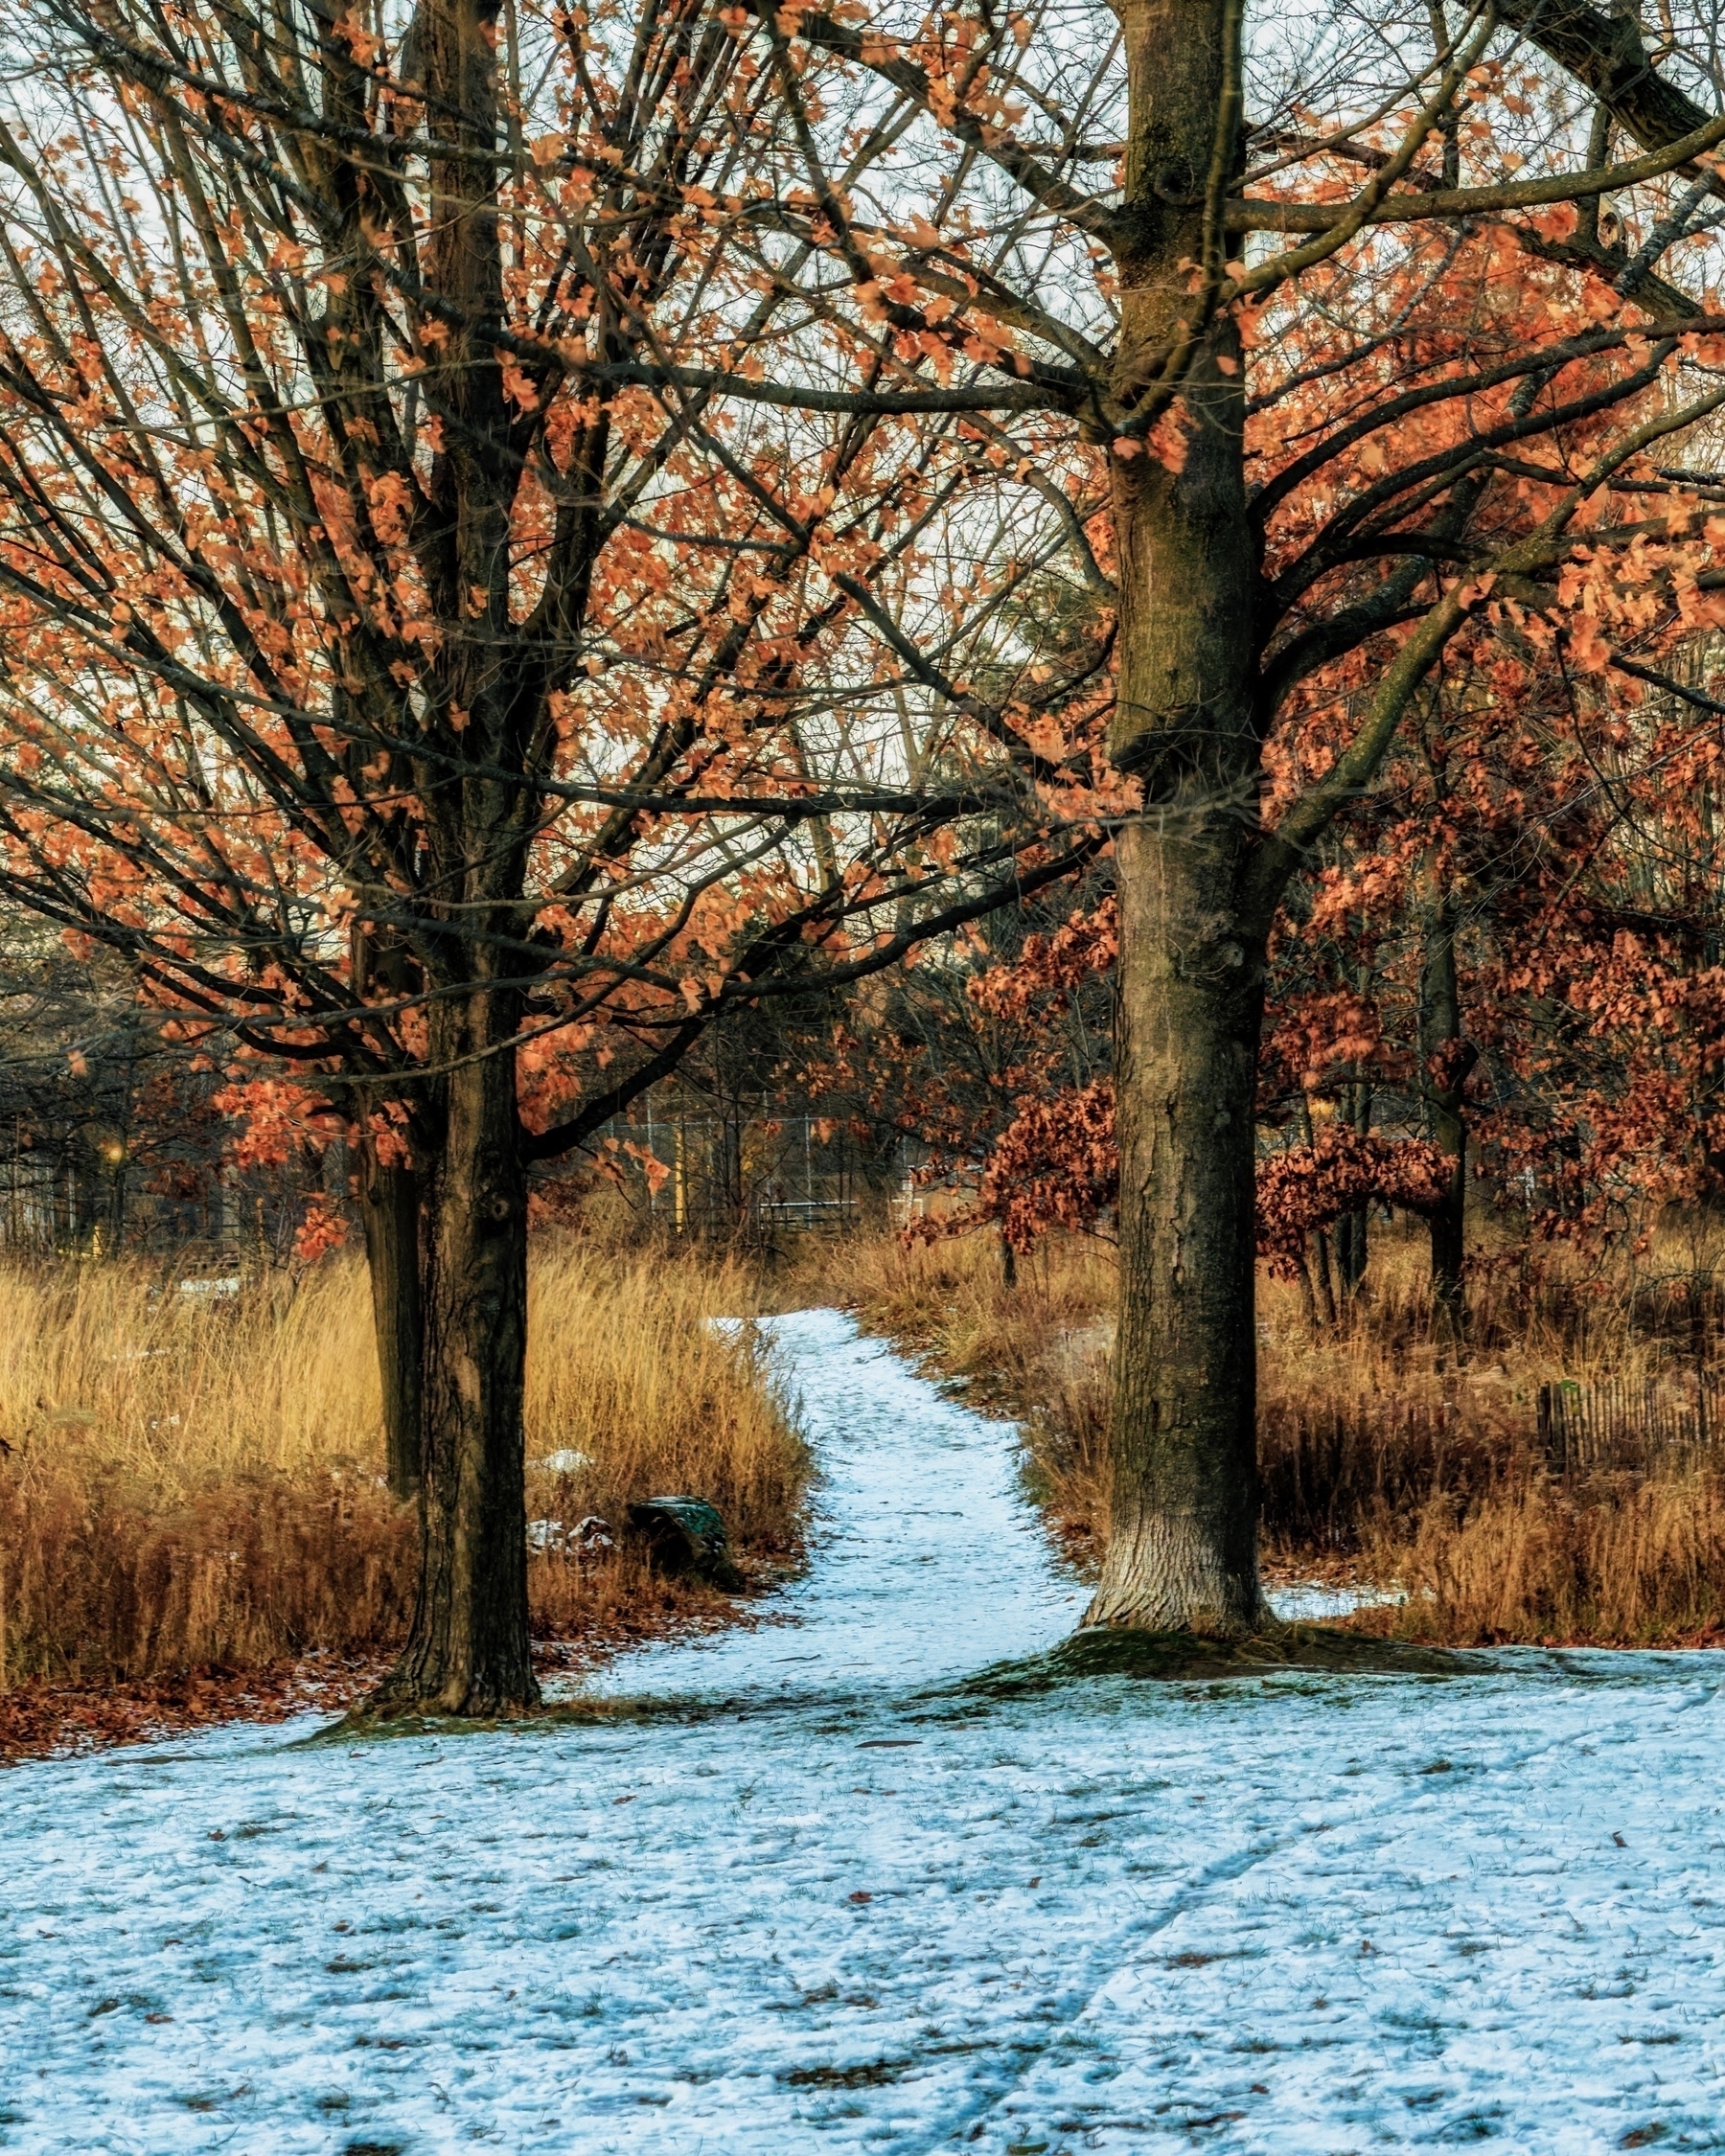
[378,0,540,1714]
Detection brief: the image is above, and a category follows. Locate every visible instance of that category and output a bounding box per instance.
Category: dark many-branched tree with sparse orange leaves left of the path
[0,0,1100,1714]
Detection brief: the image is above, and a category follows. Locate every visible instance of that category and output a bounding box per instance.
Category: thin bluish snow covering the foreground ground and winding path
[0,1311,1725,2156]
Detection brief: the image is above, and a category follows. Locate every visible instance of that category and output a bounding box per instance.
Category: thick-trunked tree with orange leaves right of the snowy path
[609,0,1725,1632]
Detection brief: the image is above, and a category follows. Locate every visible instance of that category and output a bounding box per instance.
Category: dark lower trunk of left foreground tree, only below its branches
[378,1026,540,1714]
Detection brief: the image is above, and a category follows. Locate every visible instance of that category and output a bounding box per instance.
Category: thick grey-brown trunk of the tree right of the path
[1087,0,1268,1635]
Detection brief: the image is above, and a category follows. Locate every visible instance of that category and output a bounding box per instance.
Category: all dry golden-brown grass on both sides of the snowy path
[0,1227,1725,1682]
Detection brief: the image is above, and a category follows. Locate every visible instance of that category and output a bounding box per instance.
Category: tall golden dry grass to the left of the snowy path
[0,1244,807,1682]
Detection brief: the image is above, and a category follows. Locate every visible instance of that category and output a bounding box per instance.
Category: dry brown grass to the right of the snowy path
[800,1223,1725,1645]
